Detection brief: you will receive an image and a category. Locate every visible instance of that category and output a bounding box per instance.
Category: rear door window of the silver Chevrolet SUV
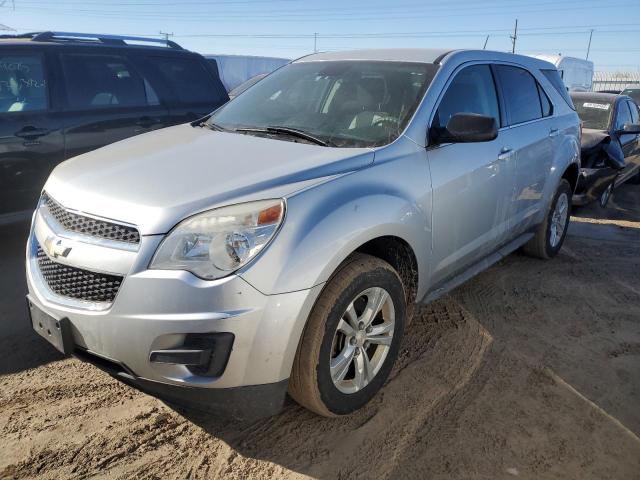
[496,65,542,125]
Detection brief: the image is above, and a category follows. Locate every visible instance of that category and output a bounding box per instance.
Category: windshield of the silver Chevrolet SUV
[209,61,438,147]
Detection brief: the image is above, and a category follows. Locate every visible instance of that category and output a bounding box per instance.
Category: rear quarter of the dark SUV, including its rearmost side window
[137,53,229,125]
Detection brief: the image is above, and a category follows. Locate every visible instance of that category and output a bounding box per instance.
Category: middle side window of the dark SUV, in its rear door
[61,54,157,109]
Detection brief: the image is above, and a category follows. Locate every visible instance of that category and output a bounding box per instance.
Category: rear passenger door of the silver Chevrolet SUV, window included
[494,65,560,236]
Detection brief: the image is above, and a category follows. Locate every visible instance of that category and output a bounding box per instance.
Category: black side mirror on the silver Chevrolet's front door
[431,113,498,143]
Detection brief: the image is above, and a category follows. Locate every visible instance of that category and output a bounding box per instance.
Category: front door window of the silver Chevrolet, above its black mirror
[432,65,500,128]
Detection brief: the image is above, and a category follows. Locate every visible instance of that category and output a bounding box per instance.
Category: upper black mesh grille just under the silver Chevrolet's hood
[42,193,140,244]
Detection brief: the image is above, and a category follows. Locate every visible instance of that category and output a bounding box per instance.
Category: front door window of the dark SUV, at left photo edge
[0,55,49,113]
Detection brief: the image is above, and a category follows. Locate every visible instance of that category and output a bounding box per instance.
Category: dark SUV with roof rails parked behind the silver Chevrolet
[0,32,229,224]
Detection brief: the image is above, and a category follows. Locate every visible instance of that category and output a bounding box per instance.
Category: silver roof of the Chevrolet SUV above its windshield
[296,48,452,63]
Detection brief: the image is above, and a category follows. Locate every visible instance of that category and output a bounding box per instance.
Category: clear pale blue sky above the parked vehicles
[0,0,640,72]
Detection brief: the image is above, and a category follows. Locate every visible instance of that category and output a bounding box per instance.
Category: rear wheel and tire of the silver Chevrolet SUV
[524,179,572,260]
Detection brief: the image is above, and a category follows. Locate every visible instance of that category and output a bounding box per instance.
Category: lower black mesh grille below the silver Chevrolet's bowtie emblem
[37,245,123,302]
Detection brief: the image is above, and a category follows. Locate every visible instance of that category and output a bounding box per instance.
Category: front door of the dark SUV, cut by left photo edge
[0,48,64,218]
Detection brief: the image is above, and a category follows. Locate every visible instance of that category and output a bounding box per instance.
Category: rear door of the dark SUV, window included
[58,48,169,157]
